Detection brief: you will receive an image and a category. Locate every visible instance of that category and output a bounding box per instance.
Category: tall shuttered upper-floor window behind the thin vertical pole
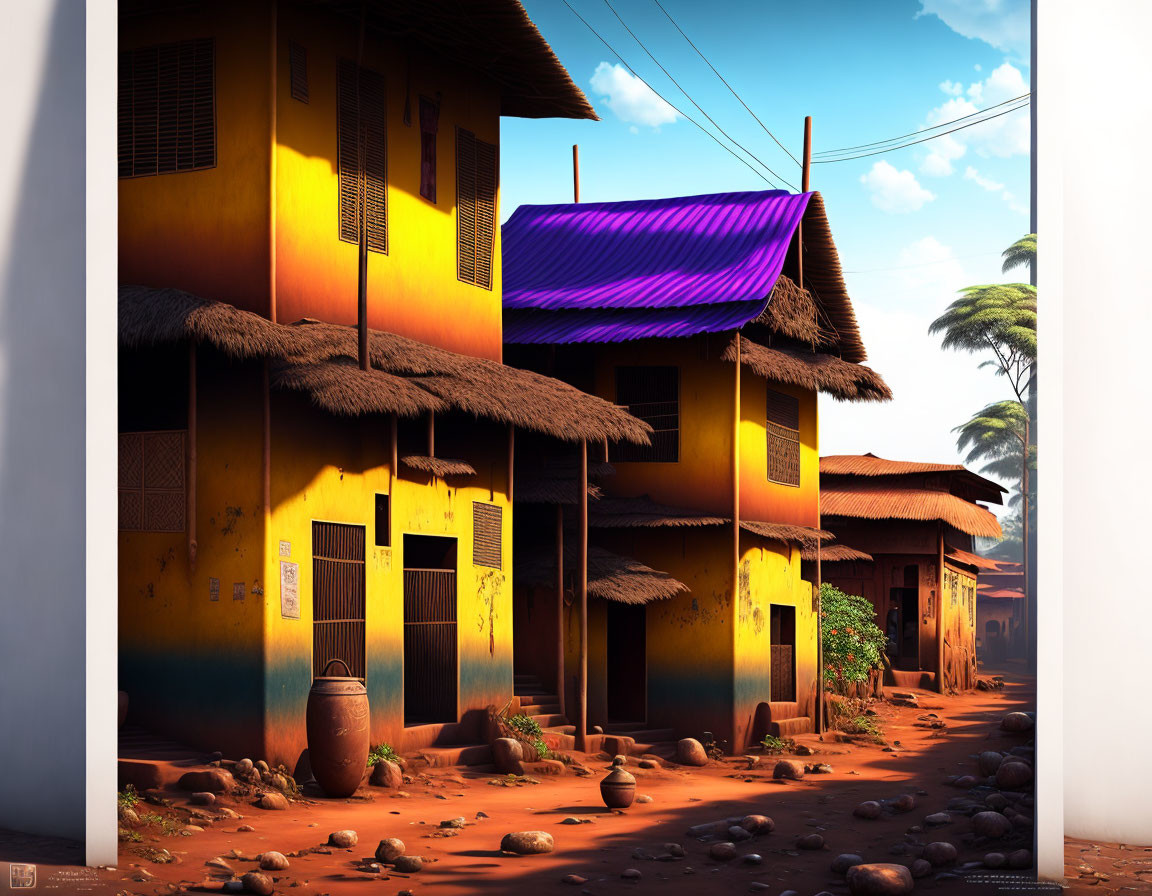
[336,59,388,253]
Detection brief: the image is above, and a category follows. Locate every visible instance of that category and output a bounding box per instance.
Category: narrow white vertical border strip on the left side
[84,0,118,865]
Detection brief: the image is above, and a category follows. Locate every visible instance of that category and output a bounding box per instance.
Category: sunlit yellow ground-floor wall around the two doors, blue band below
[264,393,513,768]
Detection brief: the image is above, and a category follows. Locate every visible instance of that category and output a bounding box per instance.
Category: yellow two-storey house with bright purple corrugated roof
[505,192,889,751]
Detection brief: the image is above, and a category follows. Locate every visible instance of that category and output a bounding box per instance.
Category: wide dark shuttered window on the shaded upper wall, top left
[116,38,217,177]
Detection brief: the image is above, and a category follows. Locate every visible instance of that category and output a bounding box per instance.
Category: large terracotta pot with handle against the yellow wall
[306,660,369,797]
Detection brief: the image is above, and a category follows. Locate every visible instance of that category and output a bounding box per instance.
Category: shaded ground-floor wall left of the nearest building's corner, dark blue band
[119,346,268,755]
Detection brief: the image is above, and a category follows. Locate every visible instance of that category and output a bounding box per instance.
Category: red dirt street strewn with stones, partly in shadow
[2,668,1101,896]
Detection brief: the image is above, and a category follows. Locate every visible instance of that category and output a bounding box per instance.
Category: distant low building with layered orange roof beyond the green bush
[820,454,1006,692]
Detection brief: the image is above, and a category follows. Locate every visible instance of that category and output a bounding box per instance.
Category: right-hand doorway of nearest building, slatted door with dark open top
[404,536,458,724]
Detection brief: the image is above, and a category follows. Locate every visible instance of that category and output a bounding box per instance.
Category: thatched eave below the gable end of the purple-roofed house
[721,337,892,401]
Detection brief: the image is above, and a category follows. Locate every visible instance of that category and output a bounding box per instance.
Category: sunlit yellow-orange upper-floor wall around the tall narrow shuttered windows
[274,5,501,360]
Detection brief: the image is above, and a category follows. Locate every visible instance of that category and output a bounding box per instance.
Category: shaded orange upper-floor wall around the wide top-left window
[119,0,272,316]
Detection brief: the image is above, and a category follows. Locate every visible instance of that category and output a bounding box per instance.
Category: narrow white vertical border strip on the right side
[1032,0,1069,881]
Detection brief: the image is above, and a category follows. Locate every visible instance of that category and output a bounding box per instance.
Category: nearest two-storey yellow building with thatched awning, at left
[119,0,647,768]
